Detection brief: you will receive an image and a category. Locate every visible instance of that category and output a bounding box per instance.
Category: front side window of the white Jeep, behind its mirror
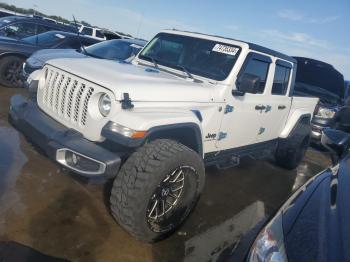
[241,58,270,94]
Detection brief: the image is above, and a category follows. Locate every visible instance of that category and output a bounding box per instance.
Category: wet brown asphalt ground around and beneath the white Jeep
[0,87,330,261]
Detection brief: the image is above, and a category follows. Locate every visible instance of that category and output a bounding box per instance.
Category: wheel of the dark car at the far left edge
[0,56,24,87]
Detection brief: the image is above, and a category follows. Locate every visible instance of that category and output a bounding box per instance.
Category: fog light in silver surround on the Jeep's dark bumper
[56,149,106,175]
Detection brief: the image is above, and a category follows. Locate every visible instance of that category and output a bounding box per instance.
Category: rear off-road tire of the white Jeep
[275,136,310,170]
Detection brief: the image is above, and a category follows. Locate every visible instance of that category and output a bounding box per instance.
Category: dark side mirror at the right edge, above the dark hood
[321,128,350,165]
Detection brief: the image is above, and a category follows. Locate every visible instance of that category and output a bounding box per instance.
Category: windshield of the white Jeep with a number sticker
[139,33,240,81]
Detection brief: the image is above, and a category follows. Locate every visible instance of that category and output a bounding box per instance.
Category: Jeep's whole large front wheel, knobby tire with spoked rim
[110,139,205,242]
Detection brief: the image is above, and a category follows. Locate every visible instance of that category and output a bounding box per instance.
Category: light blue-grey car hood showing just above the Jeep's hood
[31,49,86,64]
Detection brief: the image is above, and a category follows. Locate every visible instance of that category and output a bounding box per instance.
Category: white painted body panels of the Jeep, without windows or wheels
[34,31,317,158]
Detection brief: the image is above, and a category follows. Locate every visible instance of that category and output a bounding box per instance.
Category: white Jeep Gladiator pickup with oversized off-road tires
[10,30,317,242]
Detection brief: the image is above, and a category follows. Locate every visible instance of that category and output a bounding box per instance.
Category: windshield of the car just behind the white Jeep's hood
[85,40,142,60]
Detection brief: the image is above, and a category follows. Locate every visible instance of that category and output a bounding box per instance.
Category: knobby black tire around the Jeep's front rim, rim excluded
[110,139,205,242]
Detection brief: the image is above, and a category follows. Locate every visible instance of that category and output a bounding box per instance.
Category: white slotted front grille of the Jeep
[42,68,95,127]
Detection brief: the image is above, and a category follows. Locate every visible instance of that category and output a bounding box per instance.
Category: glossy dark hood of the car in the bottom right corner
[283,157,350,261]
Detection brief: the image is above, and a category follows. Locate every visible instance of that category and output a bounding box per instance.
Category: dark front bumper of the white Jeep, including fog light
[9,95,121,177]
